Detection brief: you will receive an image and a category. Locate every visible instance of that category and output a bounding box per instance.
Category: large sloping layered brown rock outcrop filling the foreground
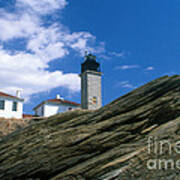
[0,76,180,180]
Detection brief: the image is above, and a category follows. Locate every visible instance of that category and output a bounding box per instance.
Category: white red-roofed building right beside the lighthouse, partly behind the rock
[34,95,81,117]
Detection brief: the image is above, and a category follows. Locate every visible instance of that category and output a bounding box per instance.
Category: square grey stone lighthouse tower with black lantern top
[80,54,102,110]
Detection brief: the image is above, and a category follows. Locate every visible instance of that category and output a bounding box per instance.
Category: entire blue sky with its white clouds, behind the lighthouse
[0,0,180,113]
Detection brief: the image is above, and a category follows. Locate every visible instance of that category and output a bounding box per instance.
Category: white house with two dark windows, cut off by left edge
[0,91,24,119]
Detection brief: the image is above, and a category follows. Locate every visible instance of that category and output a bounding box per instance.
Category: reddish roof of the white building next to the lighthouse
[34,99,81,110]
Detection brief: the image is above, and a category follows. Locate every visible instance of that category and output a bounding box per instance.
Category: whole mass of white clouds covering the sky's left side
[0,0,104,97]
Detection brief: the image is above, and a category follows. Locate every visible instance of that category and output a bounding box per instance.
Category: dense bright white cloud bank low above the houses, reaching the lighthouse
[0,47,80,97]
